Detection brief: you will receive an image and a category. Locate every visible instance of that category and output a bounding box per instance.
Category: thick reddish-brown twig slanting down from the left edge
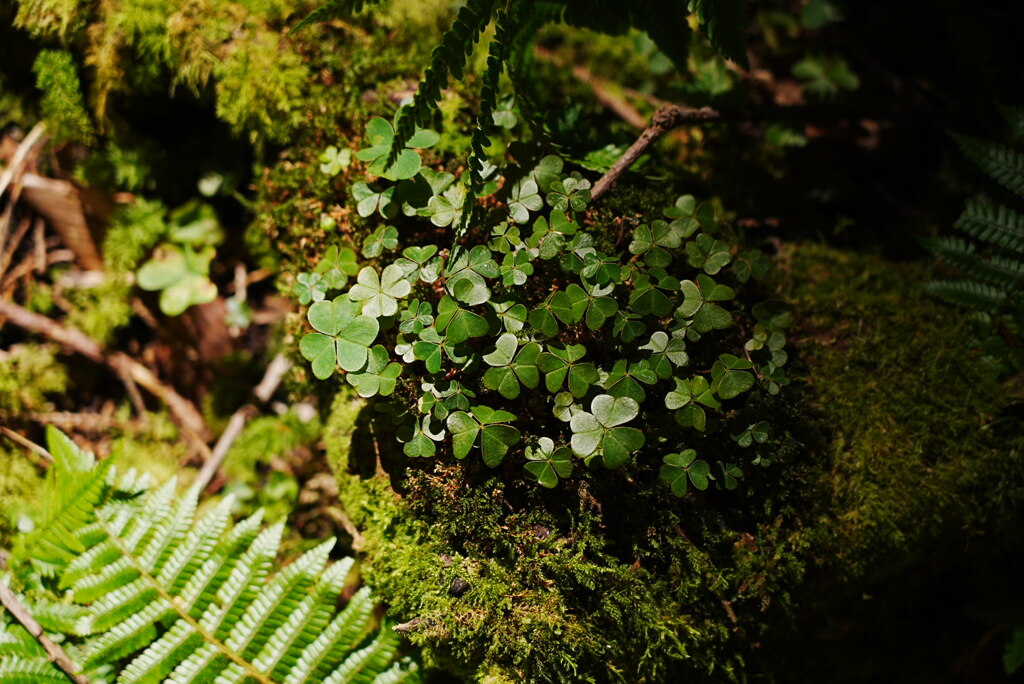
[0,301,209,440]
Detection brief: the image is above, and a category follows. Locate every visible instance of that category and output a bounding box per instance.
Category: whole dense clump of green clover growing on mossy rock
[295,119,790,497]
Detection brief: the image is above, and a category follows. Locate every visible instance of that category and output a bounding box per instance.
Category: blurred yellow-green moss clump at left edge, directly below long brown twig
[0,344,68,412]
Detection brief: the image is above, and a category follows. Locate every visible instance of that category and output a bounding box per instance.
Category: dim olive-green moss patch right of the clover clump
[781,245,1024,578]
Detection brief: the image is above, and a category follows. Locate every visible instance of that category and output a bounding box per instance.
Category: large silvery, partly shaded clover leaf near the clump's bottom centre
[569,394,644,468]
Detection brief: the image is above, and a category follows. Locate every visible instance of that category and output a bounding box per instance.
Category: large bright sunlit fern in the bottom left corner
[0,428,419,684]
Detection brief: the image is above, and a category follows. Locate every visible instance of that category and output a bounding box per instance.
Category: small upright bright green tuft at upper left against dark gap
[33,50,94,144]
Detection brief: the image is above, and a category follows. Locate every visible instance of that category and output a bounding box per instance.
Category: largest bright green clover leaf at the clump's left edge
[299,297,380,380]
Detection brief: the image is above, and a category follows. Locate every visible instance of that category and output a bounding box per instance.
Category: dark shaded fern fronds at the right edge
[925,108,1024,372]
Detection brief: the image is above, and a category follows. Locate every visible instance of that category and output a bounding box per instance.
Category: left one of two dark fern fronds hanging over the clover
[387,0,495,166]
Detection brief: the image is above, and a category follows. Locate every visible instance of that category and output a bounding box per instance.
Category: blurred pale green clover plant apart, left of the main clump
[136,201,224,315]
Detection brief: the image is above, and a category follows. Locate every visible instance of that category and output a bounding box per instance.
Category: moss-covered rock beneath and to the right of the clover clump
[326,245,1024,682]
